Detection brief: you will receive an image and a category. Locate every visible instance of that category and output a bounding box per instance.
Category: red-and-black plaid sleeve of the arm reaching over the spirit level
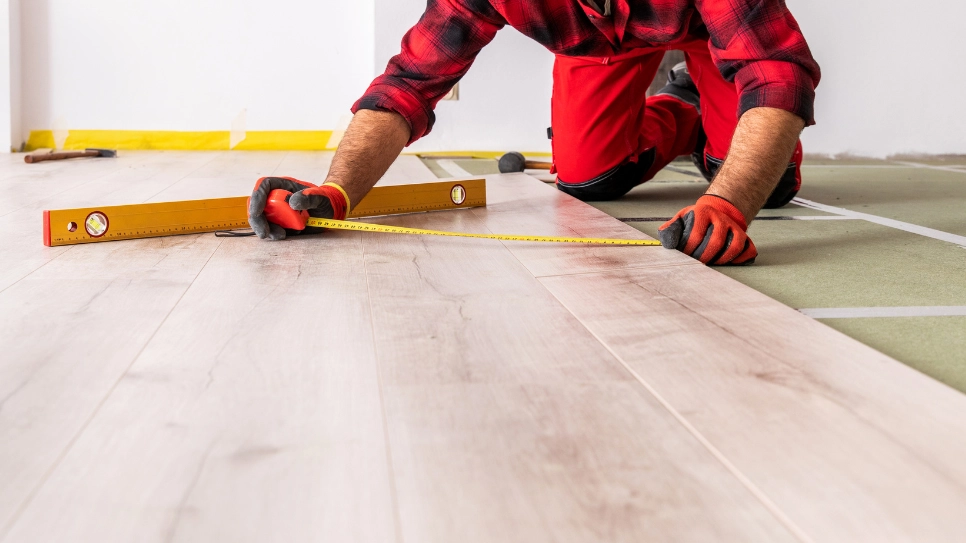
[352,0,506,145]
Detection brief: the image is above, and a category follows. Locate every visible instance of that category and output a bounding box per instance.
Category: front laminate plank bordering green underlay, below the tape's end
[541,268,966,541]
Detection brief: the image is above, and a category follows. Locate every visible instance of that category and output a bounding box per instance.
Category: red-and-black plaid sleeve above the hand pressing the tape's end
[697,0,821,125]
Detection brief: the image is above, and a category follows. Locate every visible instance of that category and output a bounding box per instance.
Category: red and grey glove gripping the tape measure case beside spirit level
[248,177,349,241]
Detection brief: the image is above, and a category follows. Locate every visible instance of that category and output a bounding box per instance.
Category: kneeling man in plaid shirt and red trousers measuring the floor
[249,0,820,265]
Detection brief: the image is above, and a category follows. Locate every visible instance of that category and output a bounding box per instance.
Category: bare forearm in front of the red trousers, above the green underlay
[708,107,805,224]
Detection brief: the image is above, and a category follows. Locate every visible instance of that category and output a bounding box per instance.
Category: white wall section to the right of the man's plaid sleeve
[788,0,966,157]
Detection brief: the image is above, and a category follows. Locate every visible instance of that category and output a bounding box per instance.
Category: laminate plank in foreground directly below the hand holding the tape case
[5,235,395,542]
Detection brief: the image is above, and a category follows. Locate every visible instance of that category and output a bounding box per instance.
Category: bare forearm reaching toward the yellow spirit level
[326,110,410,206]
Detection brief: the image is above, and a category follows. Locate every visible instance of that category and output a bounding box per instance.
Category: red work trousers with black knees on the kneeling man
[551,37,802,207]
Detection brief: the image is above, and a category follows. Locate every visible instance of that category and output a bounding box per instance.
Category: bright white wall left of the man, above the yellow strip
[22,0,374,144]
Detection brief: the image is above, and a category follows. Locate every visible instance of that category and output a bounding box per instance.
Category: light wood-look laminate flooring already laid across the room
[0,152,966,543]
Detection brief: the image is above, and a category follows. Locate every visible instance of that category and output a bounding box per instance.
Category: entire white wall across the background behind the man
[11,0,966,156]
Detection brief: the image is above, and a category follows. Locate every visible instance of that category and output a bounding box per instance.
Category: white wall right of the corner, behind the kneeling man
[376,0,966,157]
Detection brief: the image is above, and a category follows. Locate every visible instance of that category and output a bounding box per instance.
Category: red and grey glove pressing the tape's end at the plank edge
[658,194,758,266]
